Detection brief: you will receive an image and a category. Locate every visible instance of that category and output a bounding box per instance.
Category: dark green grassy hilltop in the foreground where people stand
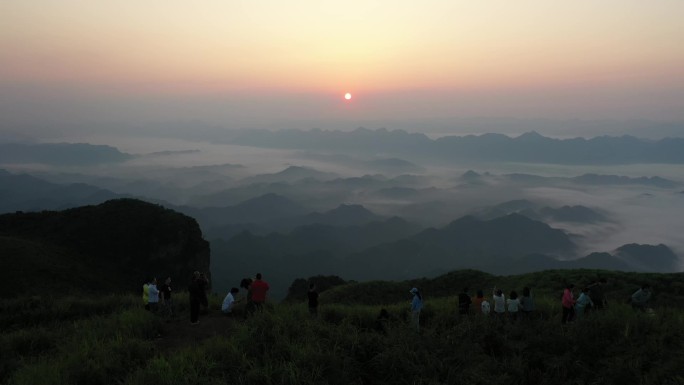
[0,270,684,385]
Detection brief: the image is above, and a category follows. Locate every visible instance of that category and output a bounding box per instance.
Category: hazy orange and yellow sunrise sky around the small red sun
[0,0,684,136]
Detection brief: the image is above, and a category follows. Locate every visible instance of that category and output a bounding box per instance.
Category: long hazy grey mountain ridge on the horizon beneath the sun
[231,128,684,164]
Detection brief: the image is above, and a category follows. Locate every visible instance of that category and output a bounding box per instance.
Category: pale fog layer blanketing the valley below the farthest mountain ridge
[2,136,684,268]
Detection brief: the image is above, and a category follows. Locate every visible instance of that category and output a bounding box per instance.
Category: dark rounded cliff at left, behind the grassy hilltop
[0,199,210,291]
